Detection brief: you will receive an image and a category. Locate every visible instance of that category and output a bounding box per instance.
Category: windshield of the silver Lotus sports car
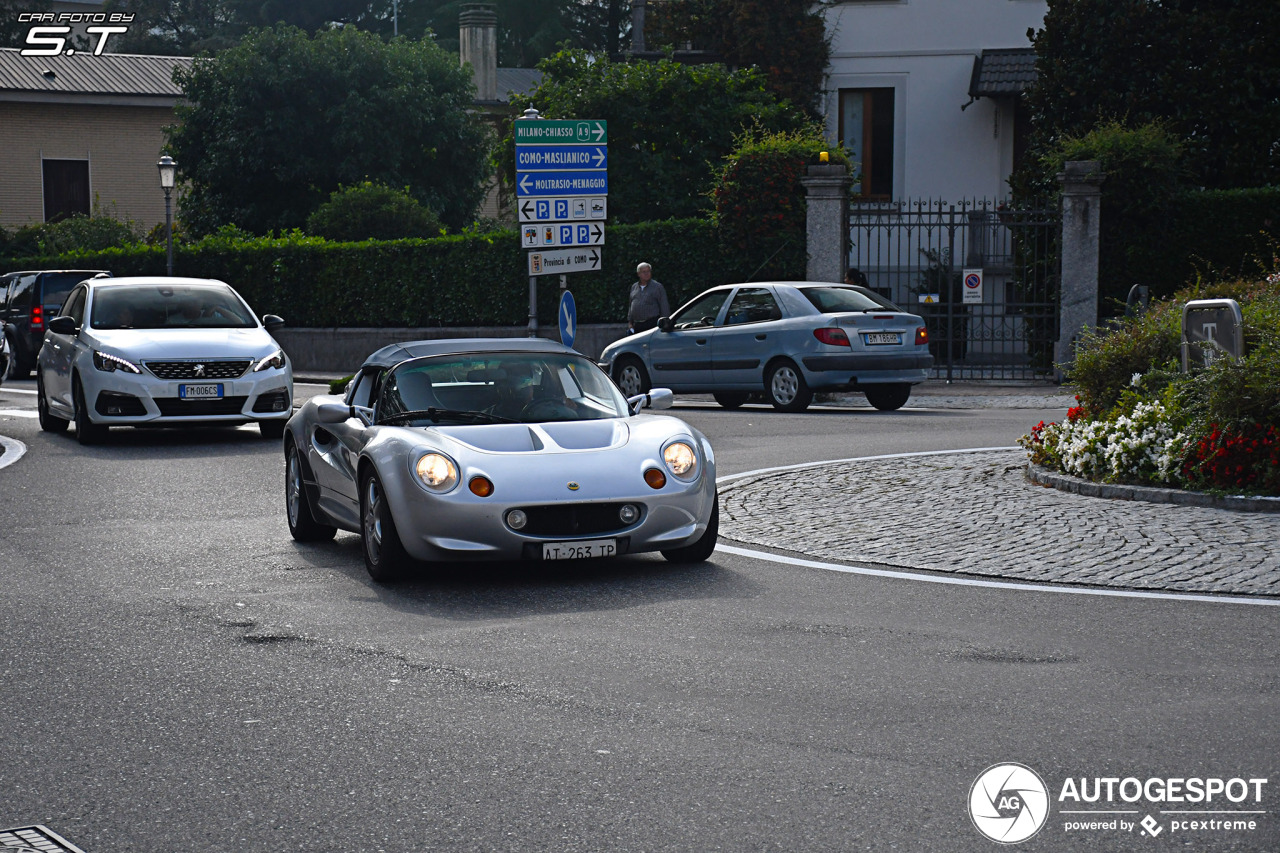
[376,352,628,427]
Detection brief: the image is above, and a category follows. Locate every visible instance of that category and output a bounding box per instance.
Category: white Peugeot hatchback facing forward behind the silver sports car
[36,277,293,444]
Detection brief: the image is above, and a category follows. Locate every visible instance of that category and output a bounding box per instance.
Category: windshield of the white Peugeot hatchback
[88,284,257,329]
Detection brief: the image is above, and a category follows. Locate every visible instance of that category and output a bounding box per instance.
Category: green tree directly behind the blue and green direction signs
[499,50,803,222]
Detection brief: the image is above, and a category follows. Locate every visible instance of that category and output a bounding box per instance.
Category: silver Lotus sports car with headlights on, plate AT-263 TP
[284,338,719,581]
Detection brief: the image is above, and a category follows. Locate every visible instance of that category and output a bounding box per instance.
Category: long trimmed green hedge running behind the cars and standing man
[0,219,804,328]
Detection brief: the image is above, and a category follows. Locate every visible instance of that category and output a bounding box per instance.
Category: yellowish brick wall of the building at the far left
[0,102,177,229]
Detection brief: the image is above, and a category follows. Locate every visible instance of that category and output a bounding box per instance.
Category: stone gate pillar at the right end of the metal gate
[1053,160,1106,379]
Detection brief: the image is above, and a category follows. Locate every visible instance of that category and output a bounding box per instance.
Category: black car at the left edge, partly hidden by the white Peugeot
[0,269,110,379]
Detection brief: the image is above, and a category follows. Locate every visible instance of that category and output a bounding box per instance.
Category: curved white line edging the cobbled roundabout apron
[716,447,1280,607]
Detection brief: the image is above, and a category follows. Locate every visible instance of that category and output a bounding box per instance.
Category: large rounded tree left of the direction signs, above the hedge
[168,27,489,236]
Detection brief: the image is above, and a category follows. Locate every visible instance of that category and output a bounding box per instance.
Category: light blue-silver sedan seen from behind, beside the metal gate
[600,282,933,411]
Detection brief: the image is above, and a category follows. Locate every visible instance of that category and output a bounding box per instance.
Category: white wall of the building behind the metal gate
[824,0,1047,201]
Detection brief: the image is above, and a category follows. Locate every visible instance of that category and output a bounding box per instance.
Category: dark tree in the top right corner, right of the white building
[1027,0,1280,188]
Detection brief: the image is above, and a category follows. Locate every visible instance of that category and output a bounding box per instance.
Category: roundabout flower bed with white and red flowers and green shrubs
[1019,273,1280,496]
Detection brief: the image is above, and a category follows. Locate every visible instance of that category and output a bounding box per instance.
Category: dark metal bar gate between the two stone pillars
[849,199,1061,380]
